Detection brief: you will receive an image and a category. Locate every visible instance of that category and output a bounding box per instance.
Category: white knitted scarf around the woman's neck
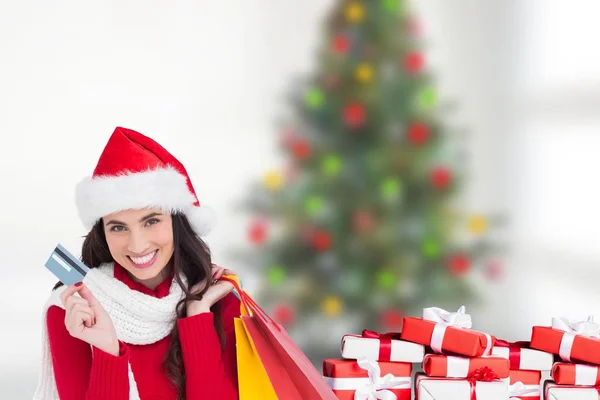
[33,263,185,400]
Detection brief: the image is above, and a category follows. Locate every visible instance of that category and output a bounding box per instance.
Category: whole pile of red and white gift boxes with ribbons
[323,307,600,400]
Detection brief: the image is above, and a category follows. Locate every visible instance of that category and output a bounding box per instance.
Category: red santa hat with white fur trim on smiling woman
[75,127,216,236]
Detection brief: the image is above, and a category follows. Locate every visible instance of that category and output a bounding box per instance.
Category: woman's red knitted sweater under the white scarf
[47,263,240,400]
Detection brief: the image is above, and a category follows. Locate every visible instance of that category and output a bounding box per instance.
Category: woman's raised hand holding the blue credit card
[60,282,119,356]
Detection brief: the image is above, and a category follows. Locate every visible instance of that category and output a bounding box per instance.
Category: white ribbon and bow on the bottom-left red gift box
[324,358,411,400]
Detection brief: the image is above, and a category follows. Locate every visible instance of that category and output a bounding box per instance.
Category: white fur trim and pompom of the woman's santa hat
[75,167,216,236]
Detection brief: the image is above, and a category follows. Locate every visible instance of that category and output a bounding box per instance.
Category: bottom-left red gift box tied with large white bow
[323,358,412,400]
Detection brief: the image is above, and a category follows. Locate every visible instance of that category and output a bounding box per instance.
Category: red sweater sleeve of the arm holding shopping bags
[177,294,240,400]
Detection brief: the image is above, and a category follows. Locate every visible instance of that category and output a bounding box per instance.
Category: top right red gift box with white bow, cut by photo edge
[531,317,600,364]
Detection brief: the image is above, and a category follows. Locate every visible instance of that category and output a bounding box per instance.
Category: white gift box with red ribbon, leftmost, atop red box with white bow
[341,335,425,363]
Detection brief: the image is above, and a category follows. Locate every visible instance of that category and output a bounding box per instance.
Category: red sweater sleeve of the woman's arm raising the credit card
[46,306,129,400]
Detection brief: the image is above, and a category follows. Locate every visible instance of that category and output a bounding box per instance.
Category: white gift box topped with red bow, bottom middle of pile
[415,373,508,400]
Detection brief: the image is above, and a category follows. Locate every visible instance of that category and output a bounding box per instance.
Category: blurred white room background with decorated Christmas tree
[0,0,600,399]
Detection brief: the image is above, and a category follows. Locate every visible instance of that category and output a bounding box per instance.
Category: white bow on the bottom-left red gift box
[354,358,410,400]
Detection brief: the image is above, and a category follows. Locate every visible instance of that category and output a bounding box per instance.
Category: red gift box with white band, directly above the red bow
[423,354,509,379]
